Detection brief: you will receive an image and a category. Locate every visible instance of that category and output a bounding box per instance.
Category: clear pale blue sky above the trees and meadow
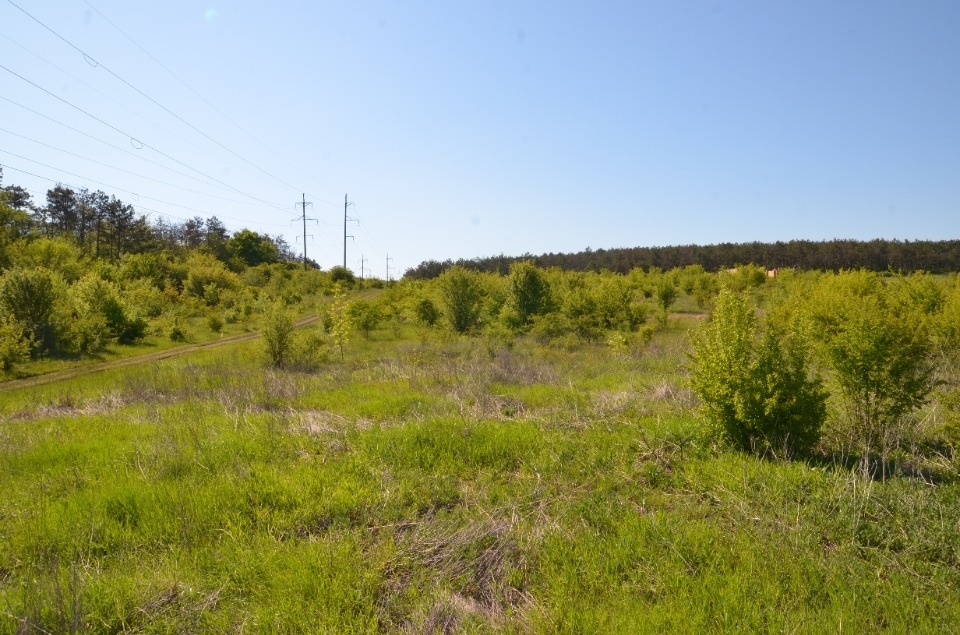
[0,0,960,277]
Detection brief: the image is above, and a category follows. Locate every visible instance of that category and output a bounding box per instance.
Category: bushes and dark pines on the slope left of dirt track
[0,172,330,377]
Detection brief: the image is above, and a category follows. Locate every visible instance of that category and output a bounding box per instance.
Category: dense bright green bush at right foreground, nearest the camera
[691,289,826,456]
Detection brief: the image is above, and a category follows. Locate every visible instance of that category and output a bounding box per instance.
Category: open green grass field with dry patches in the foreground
[0,314,960,633]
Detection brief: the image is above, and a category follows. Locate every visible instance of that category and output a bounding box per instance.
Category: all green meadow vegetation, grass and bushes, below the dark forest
[0,181,960,633]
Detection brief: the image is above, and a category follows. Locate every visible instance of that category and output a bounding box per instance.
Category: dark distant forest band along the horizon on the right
[405,239,960,279]
